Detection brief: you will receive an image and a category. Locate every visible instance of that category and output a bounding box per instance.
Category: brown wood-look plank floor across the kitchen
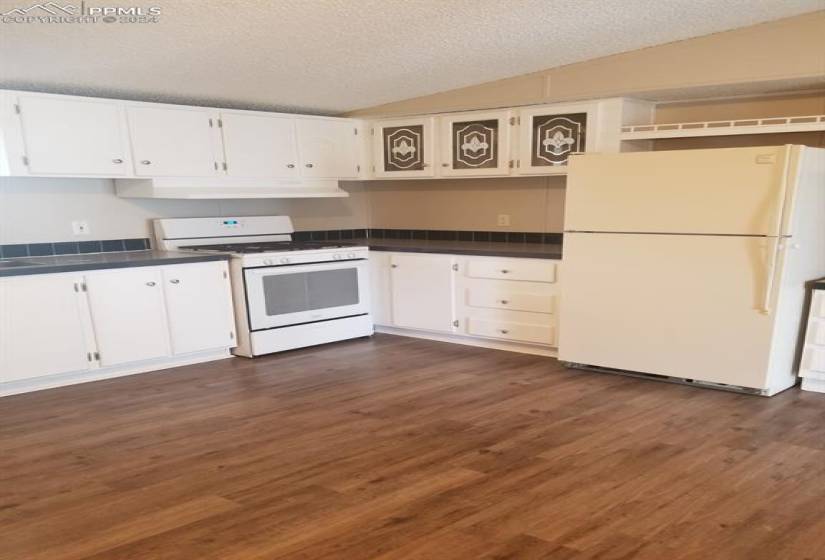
[0,335,825,560]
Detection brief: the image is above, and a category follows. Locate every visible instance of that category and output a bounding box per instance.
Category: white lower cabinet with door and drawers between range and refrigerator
[370,251,560,348]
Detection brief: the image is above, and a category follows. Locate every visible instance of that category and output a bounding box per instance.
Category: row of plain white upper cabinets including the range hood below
[0,90,366,198]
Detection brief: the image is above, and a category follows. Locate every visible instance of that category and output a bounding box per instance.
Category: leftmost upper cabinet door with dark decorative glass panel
[372,117,435,178]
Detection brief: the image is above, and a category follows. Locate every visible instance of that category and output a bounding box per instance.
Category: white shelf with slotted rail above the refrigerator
[621,115,825,140]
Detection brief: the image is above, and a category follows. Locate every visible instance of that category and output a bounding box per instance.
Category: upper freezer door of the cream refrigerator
[565,146,800,235]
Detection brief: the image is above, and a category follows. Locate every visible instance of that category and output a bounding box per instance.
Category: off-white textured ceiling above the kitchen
[0,0,825,113]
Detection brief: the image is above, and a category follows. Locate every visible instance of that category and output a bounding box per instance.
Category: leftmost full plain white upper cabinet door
[19,95,131,176]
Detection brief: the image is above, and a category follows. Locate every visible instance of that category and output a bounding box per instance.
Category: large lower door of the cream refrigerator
[559,233,774,389]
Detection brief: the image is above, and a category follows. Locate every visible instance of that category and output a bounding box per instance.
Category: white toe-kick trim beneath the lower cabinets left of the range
[0,348,233,397]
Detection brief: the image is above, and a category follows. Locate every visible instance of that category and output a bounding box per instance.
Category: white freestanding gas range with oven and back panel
[155,216,373,357]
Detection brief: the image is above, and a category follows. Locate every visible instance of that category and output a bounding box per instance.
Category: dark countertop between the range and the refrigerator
[345,238,562,259]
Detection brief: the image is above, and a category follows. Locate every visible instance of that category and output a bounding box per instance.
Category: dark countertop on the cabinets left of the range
[0,251,229,277]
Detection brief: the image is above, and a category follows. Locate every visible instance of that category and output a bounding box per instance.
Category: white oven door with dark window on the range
[244,259,369,331]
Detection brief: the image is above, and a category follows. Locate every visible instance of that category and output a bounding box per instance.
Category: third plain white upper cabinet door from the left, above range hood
[221,112,299,178]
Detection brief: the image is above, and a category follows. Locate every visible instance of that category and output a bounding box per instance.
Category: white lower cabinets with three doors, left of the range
[0,261,235,394]
